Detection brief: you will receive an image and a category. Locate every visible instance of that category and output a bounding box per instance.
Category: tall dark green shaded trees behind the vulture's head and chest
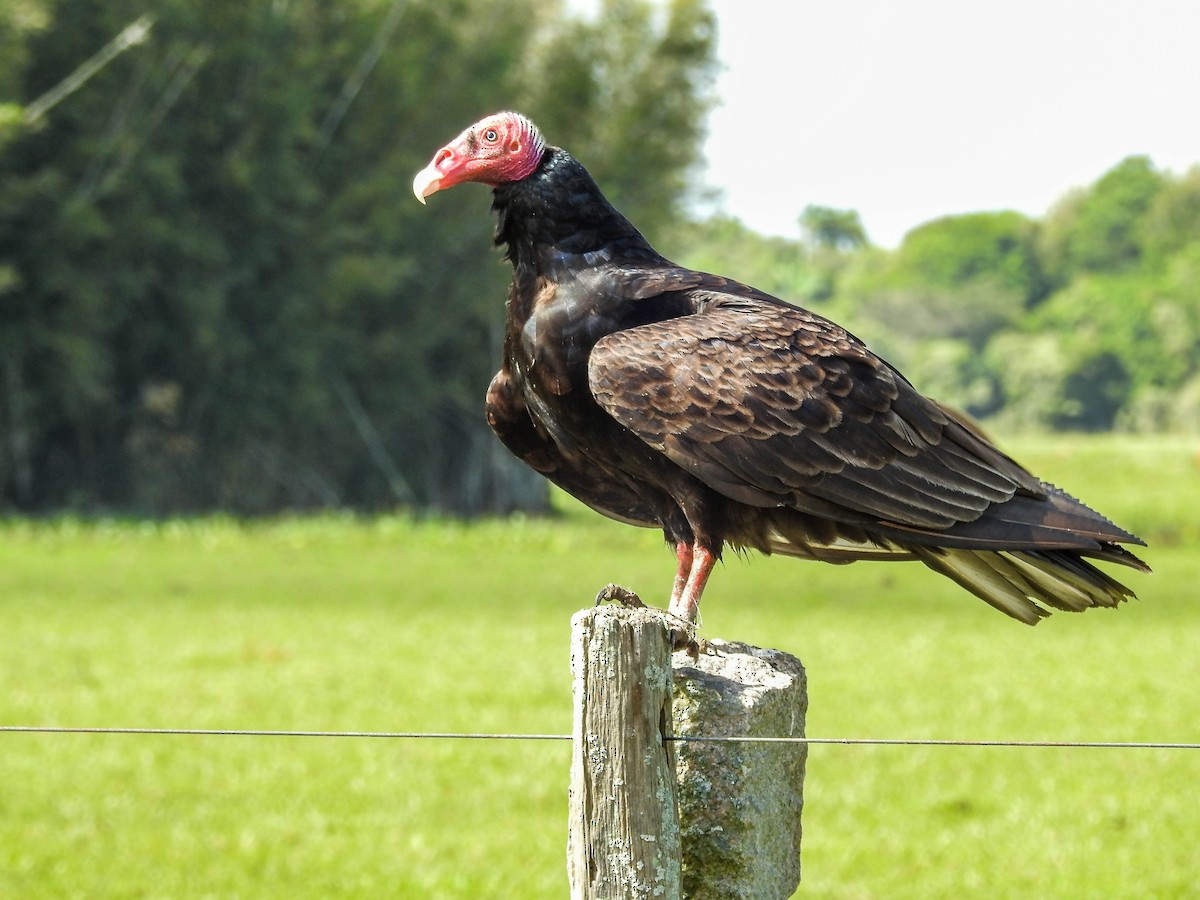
[0,0,714,512]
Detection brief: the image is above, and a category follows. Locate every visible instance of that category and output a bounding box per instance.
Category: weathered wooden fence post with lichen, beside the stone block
[566,606,682,900]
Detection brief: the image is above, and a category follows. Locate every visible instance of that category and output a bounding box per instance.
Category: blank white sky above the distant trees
[707,0,1200,246]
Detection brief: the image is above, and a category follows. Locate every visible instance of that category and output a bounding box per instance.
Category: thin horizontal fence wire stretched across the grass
[0,725,1200,750]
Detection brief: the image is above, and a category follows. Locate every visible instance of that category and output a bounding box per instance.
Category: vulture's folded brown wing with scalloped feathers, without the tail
[588,296,1042,529]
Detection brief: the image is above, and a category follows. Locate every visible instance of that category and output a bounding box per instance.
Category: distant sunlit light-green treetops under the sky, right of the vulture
[690,156,1200,441]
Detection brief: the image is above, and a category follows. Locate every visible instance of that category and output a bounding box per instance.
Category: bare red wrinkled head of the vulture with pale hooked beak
[413,112,546,203]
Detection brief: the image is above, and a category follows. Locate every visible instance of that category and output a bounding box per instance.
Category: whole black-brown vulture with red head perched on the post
[413,112,1148,625]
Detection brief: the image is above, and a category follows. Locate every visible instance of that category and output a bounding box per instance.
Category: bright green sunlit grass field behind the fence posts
[0,438,1200,898]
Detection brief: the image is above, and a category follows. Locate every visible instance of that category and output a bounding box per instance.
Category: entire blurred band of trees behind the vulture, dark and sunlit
[0,0,1200,515]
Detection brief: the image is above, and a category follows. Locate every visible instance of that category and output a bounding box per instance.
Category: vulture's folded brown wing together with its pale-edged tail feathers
[589,289,1145,623]
